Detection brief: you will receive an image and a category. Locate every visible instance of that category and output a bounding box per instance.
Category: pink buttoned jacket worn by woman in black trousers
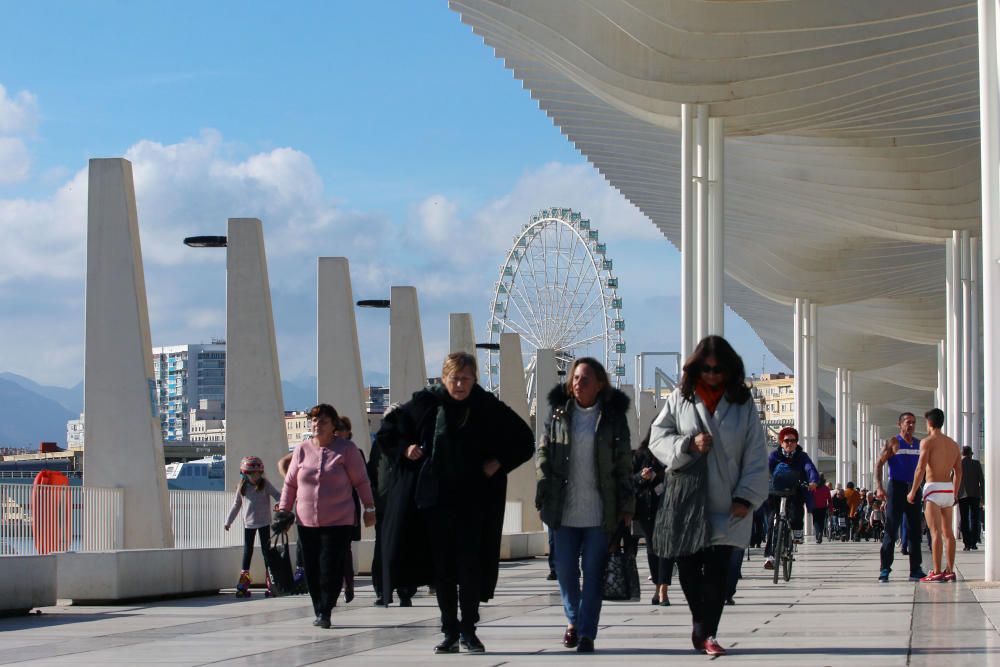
[278,438,375,528]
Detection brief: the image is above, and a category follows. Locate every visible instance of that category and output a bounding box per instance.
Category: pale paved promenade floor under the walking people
[0,543,1000,667]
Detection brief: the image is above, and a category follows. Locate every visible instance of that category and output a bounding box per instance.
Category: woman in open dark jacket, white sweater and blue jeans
[535,357,635,653]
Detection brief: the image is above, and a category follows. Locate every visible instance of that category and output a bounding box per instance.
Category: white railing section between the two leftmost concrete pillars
[170,489,243,549]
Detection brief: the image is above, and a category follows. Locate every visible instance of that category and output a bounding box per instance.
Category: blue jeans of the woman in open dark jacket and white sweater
[553,526,608,639]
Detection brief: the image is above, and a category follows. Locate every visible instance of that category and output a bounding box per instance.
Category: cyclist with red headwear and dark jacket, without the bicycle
[764,426,819,570]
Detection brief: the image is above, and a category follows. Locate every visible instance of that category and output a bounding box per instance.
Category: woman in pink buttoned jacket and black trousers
[278,403,375,628]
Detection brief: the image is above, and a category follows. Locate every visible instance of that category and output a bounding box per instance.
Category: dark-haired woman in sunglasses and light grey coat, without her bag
[649,336,767,655]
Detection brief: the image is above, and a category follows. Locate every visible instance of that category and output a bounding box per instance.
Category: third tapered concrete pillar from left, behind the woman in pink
[316,257,371,457]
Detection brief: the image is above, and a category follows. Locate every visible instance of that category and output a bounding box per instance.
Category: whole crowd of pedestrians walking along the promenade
[217,336,984,656]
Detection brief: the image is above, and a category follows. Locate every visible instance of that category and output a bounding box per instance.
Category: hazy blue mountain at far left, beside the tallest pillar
[0,373,74,450]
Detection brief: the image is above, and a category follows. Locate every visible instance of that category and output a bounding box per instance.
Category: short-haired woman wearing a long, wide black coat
[377,352,534,653]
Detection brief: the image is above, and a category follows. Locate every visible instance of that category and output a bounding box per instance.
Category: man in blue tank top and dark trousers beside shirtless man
[875,412,926,583]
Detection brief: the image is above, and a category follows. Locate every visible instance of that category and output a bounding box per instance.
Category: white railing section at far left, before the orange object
[0,484,124,556]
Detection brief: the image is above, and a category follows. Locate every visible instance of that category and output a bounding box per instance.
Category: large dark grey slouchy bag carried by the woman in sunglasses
[653,412,711,558]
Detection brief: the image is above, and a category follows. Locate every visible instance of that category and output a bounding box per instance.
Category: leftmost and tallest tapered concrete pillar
[83,158,174,549]
